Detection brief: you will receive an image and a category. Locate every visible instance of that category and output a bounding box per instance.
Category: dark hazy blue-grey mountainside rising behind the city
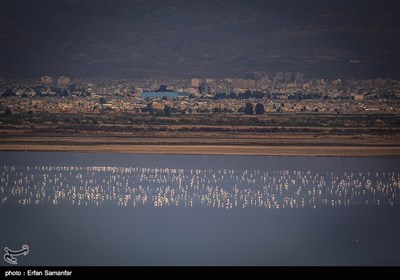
[0,0,400,78]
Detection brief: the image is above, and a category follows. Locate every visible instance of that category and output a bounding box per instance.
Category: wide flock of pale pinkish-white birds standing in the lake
[0,166,400,209]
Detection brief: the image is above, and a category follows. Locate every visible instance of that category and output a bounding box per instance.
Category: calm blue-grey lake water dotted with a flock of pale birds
[0,152,400,266]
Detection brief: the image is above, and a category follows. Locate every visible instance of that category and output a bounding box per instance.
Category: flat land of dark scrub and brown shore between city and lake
[0,114,400,157]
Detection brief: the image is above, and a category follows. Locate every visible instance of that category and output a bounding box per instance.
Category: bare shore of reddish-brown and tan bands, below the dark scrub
[0,132,400,157]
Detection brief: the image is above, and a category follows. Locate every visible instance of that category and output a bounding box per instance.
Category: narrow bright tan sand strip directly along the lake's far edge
[0,144,400,157]
